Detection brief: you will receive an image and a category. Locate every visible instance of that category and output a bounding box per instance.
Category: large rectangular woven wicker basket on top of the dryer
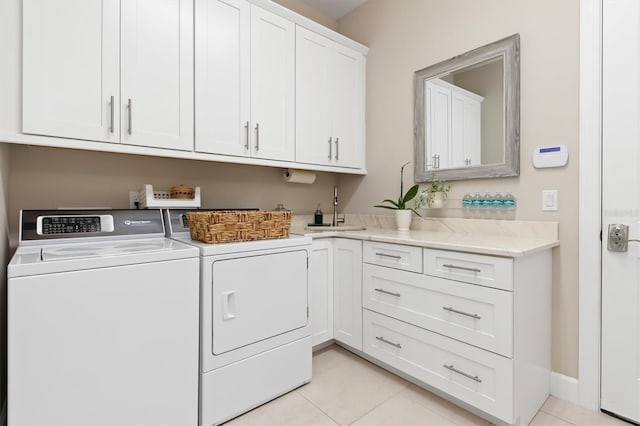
[187,210,291,244]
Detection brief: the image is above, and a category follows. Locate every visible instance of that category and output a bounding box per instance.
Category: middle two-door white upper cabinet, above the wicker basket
[195,0,295,161]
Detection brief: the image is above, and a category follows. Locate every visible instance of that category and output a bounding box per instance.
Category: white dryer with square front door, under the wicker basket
[165,210,312,425]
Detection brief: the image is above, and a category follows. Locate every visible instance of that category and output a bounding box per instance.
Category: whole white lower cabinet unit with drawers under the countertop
[311,238,551,425]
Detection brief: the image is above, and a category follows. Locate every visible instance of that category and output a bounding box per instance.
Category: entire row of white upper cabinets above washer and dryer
[18,0,368,174]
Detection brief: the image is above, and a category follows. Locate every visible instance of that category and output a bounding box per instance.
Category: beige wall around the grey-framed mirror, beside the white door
[338,0,579,377]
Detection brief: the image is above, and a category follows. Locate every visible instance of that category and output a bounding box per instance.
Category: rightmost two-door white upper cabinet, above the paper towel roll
[296,26,365,168]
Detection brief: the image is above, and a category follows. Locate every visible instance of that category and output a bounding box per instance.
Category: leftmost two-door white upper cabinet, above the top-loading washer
[23,0,193,150]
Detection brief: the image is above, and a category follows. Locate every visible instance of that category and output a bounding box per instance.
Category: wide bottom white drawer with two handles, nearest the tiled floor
[363,309,513,423]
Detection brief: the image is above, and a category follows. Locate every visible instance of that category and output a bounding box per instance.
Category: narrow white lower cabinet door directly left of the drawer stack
[333,238,362,351]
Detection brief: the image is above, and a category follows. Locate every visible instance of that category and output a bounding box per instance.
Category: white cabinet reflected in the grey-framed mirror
[425,79,484,170]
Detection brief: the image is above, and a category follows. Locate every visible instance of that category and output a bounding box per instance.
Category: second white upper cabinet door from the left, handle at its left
[120,0,193,151]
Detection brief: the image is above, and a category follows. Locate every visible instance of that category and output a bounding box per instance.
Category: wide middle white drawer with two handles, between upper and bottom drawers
[362,265,513,357]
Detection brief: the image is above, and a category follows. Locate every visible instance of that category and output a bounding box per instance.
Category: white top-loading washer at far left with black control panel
[7,210,199,426]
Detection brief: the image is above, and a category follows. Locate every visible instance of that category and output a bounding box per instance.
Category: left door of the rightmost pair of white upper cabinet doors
[296,26,335,164]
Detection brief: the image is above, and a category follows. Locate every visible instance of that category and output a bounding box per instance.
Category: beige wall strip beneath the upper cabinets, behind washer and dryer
[9,145,336,237]
